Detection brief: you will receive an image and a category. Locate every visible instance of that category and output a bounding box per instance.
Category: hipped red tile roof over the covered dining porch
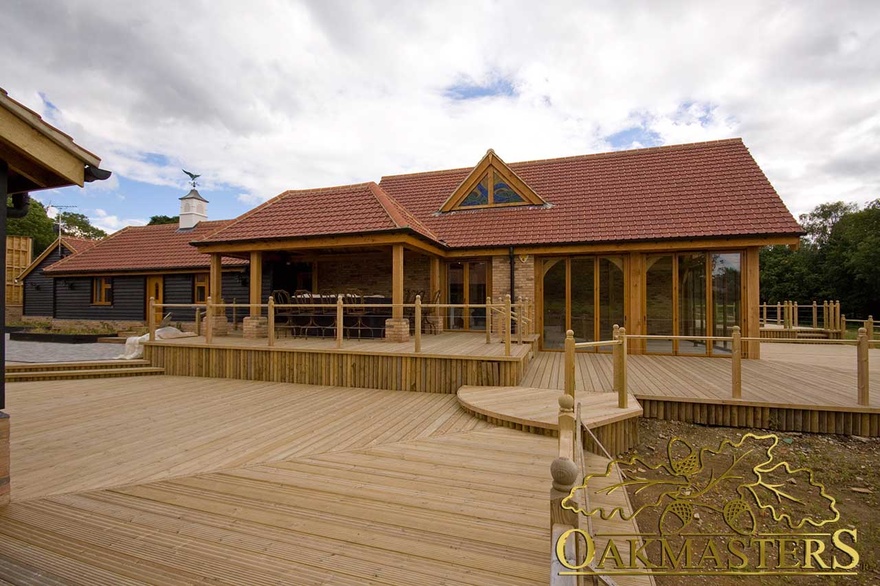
[193,182,437,243]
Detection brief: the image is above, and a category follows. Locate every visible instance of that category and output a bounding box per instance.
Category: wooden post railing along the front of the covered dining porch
[147,295,534,356]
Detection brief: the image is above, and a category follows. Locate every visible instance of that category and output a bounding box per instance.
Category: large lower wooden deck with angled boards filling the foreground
[0,376,640,586]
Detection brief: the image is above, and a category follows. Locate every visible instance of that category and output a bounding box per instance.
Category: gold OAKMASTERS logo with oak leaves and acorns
[556,433,859,576]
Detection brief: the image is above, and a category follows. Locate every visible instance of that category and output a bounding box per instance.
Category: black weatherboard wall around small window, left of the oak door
[55,276,147,321]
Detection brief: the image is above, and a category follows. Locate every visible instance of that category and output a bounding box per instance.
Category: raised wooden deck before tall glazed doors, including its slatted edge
[521,344,880,436]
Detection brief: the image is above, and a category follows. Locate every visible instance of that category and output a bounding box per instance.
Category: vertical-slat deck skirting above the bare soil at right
[638,396,880,437]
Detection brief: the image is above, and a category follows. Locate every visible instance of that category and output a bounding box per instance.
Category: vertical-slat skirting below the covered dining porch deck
[144,344,528,394]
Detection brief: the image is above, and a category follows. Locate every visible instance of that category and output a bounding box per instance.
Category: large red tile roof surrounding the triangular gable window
[374,139,802,247]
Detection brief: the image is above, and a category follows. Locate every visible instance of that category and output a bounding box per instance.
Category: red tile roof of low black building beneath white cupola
[45,220,241,275]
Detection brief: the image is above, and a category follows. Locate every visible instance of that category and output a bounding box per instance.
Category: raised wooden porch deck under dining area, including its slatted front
[144,333,532,394]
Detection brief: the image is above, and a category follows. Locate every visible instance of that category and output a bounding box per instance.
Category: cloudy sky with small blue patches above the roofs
[0,0,880,231]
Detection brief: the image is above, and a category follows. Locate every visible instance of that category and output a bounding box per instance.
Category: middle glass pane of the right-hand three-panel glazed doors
[678,253,706,354]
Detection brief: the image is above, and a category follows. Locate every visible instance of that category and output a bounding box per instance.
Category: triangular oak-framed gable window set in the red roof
[440,149,545,212]
